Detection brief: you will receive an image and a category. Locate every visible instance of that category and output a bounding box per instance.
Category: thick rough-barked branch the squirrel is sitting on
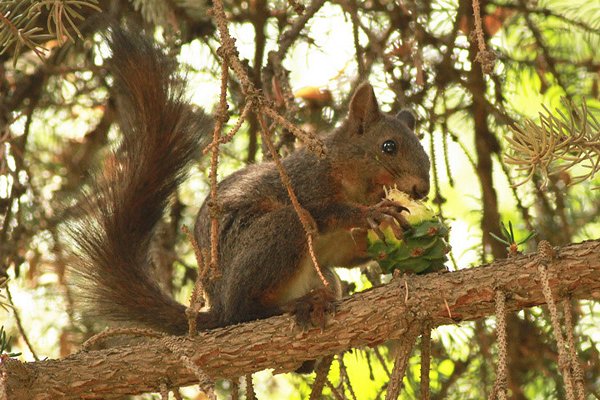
[0,239,600,399]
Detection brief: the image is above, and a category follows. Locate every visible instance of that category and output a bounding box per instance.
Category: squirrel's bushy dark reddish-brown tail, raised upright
[68,28,212,334]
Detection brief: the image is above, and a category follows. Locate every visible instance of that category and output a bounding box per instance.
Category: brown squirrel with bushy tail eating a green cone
[69,28,430,334]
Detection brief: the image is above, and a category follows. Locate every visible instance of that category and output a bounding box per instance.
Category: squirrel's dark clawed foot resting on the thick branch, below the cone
[285,288,337,330]
